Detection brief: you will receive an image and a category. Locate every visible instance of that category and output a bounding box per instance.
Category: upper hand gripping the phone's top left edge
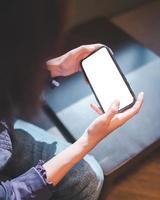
[47,44,103,77]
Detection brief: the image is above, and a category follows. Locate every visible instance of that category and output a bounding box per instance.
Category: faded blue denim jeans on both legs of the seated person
[5,120,103,200]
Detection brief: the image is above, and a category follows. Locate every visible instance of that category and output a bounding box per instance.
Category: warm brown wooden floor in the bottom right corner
[100,148,160,200]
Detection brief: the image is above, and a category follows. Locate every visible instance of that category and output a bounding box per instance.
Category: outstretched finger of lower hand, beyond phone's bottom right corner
[114,92,144,124]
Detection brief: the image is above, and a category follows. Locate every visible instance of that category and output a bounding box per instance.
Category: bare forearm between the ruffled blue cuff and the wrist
[43,134,95,185]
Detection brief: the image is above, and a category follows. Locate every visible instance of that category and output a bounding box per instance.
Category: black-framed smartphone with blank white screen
[81,46,136,112]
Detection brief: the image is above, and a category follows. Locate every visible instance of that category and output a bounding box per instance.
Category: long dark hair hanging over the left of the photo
[0,0,66,118]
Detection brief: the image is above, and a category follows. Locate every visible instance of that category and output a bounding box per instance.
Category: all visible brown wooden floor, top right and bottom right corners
[100,0,160,200]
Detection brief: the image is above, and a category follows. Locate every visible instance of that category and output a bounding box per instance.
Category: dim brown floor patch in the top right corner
[112,0,160,55]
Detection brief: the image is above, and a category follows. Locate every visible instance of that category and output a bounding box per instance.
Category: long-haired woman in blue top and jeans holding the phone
[0,0,143,200]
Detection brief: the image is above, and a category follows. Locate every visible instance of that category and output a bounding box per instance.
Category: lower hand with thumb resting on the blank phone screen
[82,92,144,146]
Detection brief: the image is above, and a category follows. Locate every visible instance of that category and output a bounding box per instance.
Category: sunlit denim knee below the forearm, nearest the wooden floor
[54,159,103,200]
